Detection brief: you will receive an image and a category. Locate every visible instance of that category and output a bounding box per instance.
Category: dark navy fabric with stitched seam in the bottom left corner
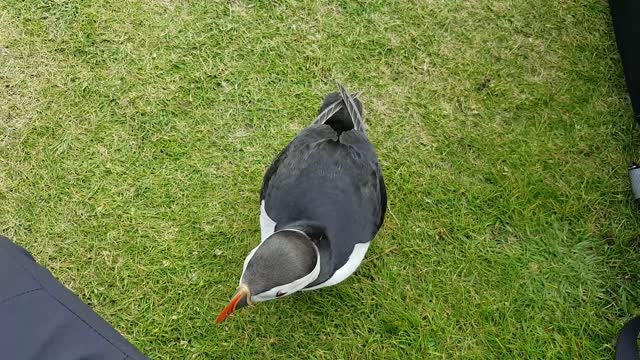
[0,236,147,360]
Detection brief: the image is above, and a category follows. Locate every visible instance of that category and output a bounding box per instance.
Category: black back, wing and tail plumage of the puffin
[260,83,387,287]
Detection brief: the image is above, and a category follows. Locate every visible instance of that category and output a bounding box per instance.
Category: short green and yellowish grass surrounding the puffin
[0,0,640,359]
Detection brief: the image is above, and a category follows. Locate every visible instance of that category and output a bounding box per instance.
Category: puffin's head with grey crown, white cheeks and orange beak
[216,230,320,323]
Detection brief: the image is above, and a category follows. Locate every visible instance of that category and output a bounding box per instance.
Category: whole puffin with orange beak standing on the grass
[216,81,387,323]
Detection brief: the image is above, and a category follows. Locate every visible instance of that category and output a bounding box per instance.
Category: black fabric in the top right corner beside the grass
[609,0,640,123]
